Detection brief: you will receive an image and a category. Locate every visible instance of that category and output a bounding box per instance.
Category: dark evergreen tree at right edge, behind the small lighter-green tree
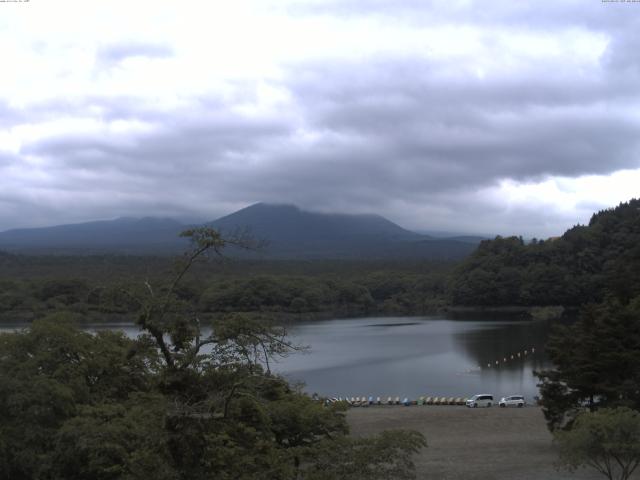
[538,296,640,430]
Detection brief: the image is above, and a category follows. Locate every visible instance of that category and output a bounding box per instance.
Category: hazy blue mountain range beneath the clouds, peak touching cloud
[0,203,477,259]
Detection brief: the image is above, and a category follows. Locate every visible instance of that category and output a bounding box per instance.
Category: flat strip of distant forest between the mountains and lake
[0,255,453,322]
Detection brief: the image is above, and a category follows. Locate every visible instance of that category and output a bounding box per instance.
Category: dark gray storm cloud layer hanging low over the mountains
[0,1,640,231]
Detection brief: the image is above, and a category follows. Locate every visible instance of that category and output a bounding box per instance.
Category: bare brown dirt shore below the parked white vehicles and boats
[347,406,624,480]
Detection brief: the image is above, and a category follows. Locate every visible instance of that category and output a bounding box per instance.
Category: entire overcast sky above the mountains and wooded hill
[0,0,640,237]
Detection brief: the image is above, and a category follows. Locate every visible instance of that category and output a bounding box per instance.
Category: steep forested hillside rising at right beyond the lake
[451,199,640,306]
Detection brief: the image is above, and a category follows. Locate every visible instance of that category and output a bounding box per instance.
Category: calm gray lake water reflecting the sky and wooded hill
[0,317,550,400]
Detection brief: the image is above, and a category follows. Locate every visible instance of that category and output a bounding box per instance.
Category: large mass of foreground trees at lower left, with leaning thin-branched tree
[0,228,425,480]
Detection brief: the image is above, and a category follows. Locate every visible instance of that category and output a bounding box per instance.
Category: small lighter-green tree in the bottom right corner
[555,407,640,480]
